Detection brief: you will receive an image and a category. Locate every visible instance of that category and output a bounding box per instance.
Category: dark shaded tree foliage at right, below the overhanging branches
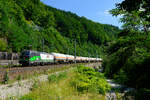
[104,31,150,88]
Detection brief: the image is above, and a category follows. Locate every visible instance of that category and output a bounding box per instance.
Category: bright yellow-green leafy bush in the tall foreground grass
[71,66,110,94]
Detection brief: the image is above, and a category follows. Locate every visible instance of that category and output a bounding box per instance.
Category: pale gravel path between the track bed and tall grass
[0,68,71,100]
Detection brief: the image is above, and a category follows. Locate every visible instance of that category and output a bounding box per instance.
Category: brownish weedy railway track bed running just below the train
[0,62,101,82]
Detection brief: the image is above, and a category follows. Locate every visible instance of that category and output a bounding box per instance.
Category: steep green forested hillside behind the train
[0,0,120,56]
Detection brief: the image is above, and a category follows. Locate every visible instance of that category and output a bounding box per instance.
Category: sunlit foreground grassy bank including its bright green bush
[16,66,109,100]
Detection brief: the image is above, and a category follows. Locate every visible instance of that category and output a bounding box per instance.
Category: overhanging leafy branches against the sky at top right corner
[110,0,150,34]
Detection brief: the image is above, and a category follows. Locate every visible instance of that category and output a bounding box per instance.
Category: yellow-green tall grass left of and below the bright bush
[19,67,105,100]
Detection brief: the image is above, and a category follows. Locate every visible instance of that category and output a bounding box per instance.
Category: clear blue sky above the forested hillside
[41,0,123,27]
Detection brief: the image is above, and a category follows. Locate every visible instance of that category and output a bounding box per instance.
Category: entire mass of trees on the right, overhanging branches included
[103,0,150,89]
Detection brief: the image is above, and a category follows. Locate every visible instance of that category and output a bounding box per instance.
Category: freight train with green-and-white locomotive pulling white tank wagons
[19,50,102,66]
